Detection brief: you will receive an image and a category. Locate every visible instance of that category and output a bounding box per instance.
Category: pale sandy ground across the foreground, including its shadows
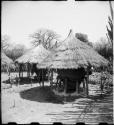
[1,74,113,124]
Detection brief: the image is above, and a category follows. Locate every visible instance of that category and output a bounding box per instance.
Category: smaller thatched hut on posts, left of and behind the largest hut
[16,44,50,86]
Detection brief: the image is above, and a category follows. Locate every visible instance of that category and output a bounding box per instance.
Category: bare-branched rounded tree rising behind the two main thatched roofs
[30,29,60,49]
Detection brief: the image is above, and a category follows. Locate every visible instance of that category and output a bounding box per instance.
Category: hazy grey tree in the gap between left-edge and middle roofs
[5,44,26,61]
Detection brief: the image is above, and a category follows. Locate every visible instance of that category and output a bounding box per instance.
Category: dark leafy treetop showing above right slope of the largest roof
[75,33,93,47]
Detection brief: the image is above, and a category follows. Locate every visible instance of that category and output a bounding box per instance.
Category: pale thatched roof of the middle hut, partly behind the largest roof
[16,44,50,63]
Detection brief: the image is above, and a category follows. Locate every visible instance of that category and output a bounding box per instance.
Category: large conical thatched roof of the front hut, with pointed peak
[38,31,108,69]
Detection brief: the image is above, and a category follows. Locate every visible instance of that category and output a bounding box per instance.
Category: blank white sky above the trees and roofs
[2,1,114,46]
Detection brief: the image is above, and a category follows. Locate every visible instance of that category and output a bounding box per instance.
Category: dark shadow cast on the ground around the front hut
[20,86,112,104]
